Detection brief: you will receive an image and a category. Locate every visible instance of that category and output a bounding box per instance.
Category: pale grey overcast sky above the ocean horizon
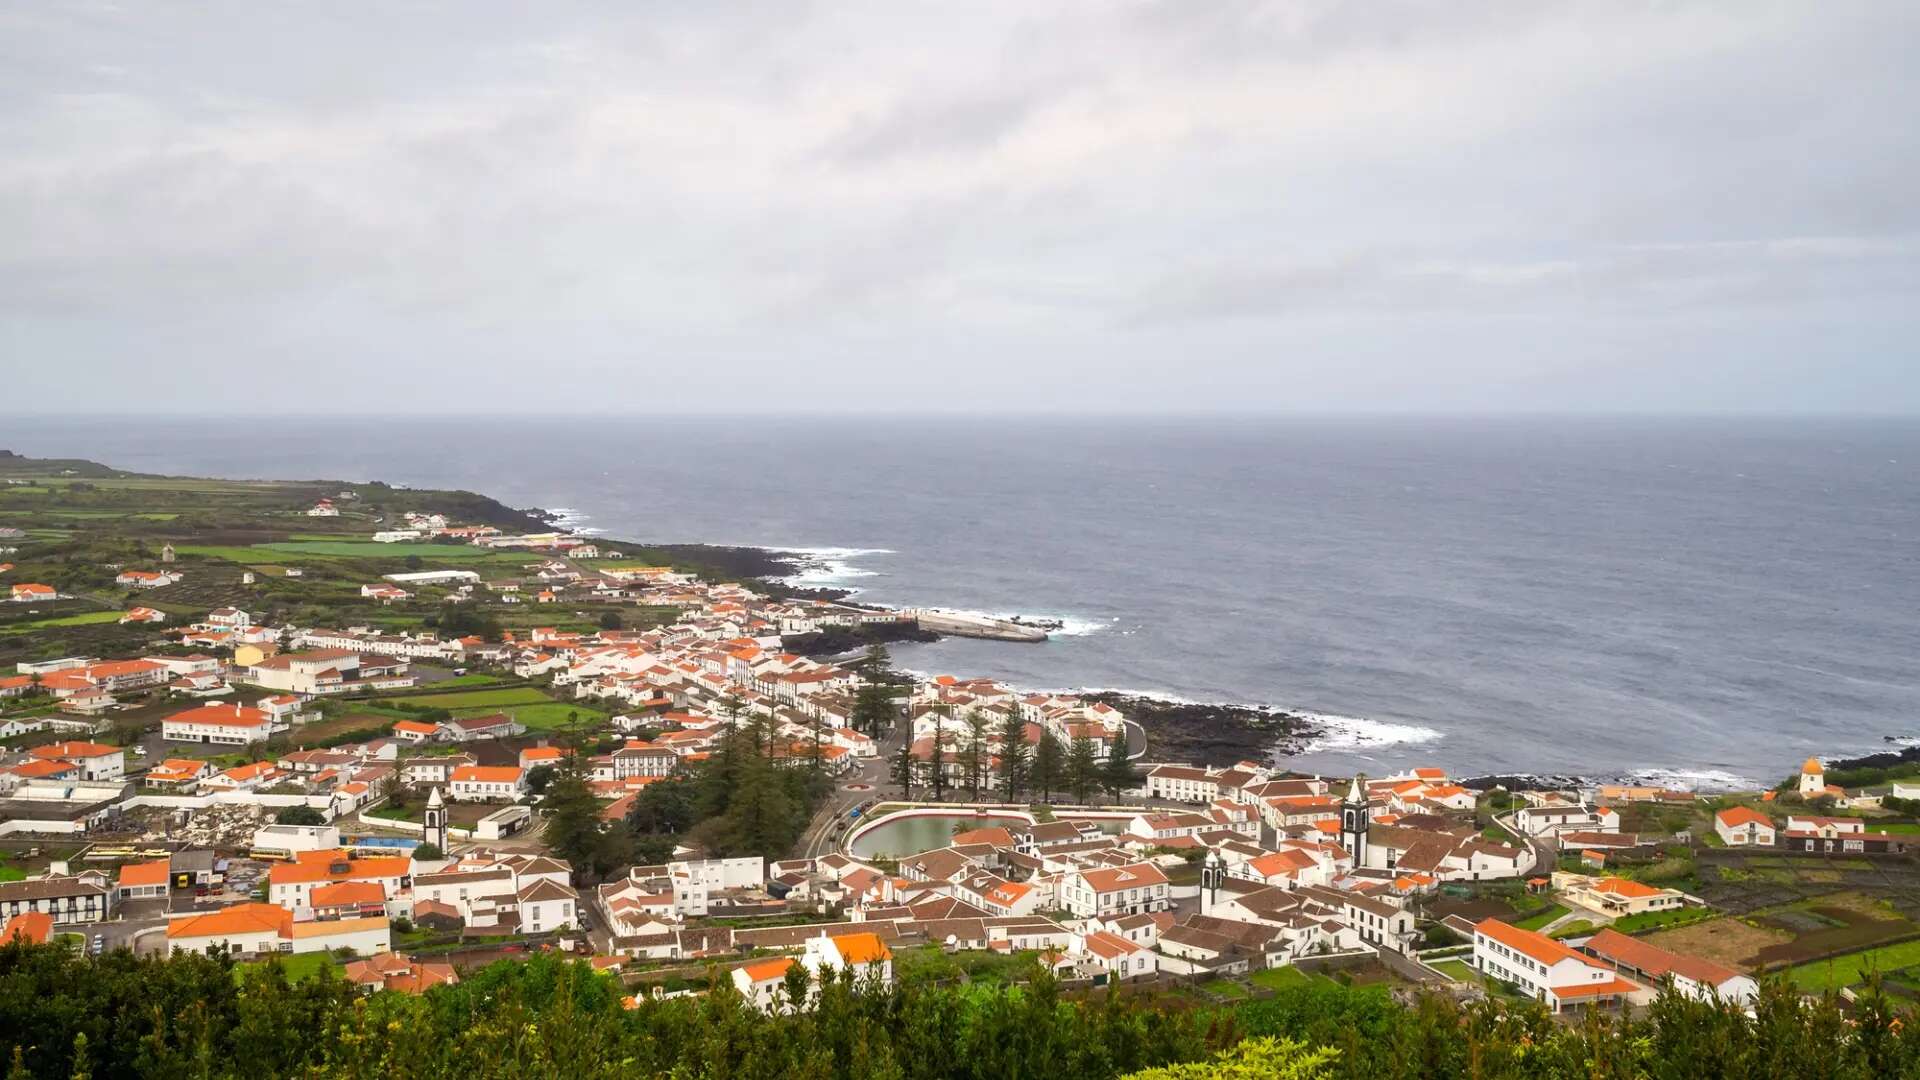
[0,0,1920,413]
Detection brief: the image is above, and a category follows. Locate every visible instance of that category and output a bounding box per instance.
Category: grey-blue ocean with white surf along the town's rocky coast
[0,417,1920,780]
